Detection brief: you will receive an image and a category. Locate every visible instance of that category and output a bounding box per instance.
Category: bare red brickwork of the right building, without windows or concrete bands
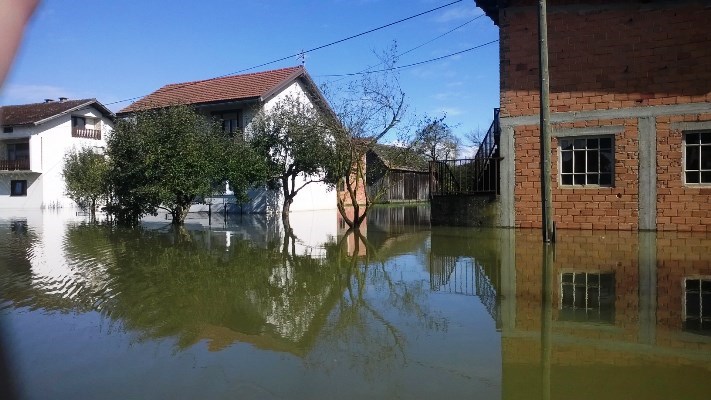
[499,0,711,231]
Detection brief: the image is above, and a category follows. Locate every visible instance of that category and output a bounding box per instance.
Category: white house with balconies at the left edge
[0,97,114,209]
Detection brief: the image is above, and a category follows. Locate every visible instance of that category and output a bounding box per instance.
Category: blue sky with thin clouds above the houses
[0,0,499,150]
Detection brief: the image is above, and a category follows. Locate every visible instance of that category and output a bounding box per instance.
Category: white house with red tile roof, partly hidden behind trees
[117,66,336,213]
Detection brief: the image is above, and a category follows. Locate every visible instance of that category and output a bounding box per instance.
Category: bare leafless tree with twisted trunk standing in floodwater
[327,52,406,228]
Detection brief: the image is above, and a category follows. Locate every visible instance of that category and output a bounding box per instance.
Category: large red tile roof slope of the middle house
[118,66,306,114]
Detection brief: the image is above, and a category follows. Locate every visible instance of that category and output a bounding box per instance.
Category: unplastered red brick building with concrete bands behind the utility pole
[476,0,711,231]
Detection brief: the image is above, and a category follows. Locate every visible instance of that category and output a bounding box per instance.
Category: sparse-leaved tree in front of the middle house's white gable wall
[250,96,332,223]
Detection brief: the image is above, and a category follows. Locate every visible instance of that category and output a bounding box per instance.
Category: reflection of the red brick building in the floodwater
[501,231,711,398]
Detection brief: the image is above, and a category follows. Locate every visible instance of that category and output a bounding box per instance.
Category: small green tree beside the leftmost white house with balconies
[62,147,109,219]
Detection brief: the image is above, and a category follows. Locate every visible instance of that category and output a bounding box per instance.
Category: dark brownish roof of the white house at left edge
[0,99,114,126]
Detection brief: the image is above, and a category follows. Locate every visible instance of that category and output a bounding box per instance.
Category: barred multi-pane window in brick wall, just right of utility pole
[558,137,615,186]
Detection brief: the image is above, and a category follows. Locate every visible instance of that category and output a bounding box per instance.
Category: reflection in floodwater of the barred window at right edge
[683,277,711,336]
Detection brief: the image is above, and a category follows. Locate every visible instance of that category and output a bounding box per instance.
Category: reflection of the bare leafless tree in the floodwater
[307,230,447,376]
